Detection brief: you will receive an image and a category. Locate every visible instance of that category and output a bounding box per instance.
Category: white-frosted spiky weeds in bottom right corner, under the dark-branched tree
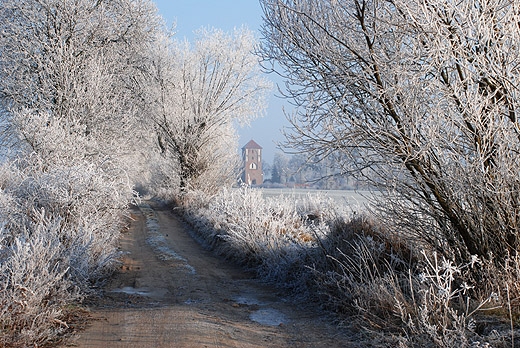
[395,252,509,348]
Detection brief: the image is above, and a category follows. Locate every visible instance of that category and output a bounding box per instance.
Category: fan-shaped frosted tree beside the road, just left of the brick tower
[144,29,270,197]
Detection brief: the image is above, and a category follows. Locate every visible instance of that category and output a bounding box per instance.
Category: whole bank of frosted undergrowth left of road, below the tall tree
[0,158,131,347]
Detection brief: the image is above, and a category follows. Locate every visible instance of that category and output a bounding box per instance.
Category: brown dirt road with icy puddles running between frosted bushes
[69,204,357,348]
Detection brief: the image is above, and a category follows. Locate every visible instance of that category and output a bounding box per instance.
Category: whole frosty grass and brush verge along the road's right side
[180,187,519,348]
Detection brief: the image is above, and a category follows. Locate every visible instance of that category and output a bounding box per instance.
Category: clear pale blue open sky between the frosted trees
[155,0,288,163]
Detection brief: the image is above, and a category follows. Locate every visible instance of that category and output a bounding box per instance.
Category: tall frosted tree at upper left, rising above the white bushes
[0,0,161,163]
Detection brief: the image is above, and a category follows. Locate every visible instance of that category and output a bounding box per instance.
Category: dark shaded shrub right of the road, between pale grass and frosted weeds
[314,215,418,322]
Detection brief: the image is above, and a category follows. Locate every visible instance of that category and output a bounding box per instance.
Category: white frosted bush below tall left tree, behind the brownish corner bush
[0,157,132,285]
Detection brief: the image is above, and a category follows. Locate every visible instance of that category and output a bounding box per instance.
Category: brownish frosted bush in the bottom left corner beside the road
[0,208,80,347]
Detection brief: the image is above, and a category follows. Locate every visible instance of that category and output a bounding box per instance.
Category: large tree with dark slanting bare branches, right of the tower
[261,0,520,261]
